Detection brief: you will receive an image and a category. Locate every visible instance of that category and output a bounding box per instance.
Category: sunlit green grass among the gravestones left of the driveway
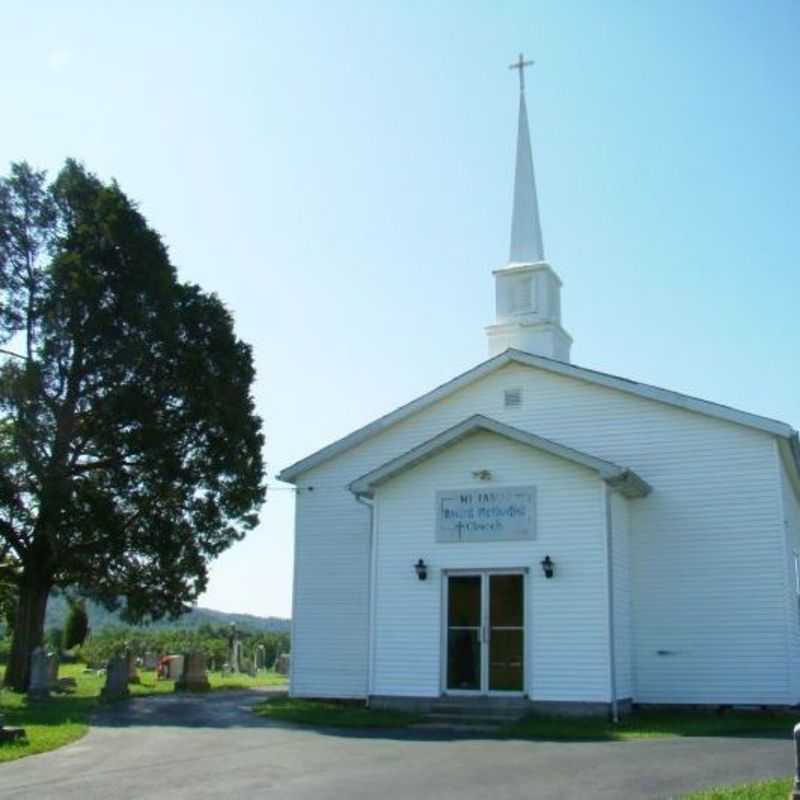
[0,664,285,762]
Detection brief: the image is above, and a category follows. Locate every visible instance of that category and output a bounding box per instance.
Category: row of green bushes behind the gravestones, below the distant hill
[80,625,289,669]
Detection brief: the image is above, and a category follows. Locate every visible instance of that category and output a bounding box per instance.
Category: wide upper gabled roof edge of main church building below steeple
[277,349,800,483]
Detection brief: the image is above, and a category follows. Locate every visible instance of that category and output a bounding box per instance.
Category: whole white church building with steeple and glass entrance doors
[278,59,800,712]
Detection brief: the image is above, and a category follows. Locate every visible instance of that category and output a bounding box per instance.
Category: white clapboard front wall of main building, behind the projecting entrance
[292,364,797,703]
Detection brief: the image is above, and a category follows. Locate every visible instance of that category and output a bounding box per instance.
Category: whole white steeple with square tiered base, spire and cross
[486,53,572,361]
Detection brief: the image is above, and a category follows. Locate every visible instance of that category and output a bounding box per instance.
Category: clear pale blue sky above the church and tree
[0,0,800,615]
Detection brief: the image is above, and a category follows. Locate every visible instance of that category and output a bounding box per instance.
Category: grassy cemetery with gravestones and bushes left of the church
[0,629,288,763]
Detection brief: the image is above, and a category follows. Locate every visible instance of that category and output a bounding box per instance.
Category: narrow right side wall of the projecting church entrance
[610,493,635,700]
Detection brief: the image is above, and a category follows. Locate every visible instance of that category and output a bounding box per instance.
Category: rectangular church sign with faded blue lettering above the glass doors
[436,486,536,542]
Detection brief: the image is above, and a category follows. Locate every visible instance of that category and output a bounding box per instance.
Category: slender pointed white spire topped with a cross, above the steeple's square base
[508,53,544,264]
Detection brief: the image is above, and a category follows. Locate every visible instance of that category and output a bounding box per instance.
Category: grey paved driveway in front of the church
[0,692,793,800]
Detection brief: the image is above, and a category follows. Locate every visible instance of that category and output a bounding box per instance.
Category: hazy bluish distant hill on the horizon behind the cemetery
[44,594,290,633]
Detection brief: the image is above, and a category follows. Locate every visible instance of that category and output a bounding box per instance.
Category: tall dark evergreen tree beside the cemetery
[0,161,264,690]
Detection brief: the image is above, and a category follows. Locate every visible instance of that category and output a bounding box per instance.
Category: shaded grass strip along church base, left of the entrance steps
[253,697,420,728]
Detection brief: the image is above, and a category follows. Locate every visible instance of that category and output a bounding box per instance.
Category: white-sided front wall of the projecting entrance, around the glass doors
[373,433,609,702]
